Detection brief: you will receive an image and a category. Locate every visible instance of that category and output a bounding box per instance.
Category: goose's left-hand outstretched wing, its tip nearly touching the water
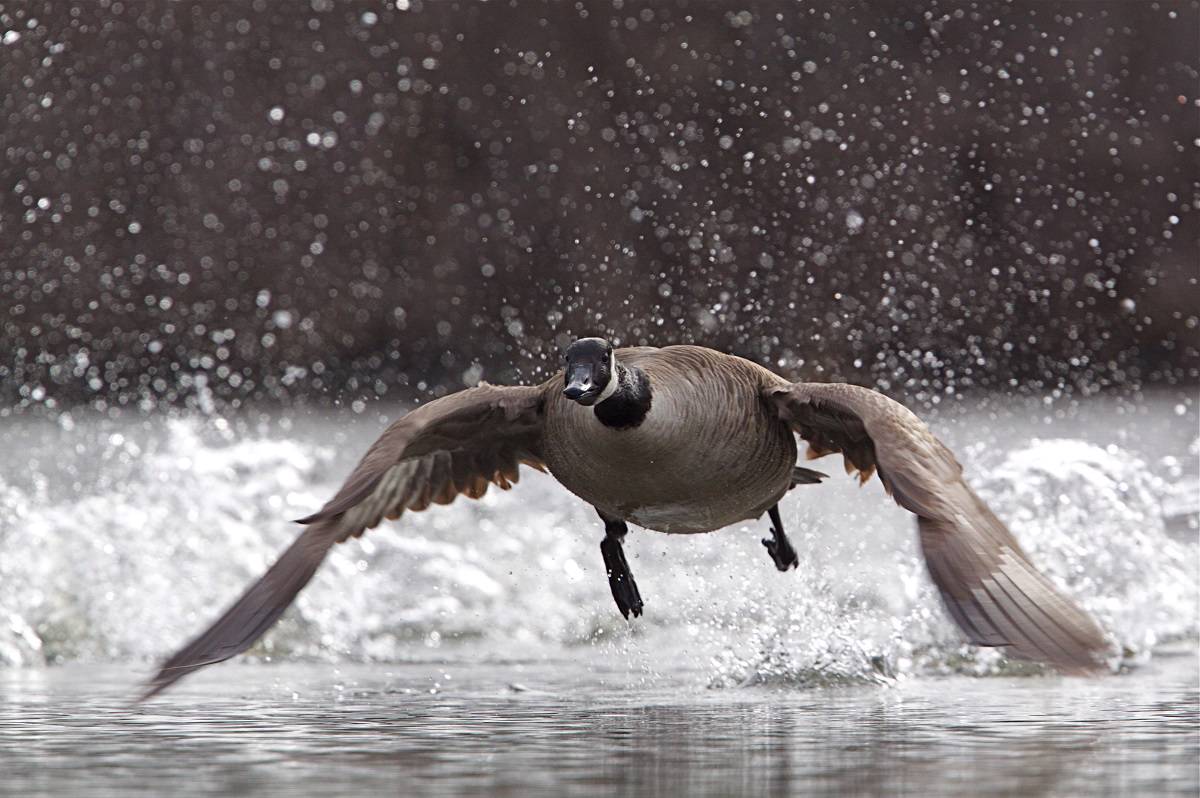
[142,385,545,700]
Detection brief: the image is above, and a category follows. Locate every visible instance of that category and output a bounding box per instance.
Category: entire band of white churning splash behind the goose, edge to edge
[0,412,1200,686]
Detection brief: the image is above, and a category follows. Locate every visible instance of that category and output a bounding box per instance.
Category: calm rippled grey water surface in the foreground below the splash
[0,654,1200,796]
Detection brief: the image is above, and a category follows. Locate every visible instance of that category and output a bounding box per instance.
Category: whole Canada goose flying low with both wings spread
[143,338,1105,698]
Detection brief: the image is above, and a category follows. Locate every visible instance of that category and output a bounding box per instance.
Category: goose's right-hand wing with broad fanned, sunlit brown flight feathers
[766,383,1105,672]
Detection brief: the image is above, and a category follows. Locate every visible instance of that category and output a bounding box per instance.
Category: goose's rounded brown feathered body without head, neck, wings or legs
[542,346,796,533]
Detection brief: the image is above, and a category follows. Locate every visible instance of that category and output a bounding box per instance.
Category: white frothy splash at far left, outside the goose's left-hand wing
[0,420,328,664]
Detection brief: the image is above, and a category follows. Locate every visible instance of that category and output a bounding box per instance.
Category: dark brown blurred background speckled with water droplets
[0,0,1200,412]
